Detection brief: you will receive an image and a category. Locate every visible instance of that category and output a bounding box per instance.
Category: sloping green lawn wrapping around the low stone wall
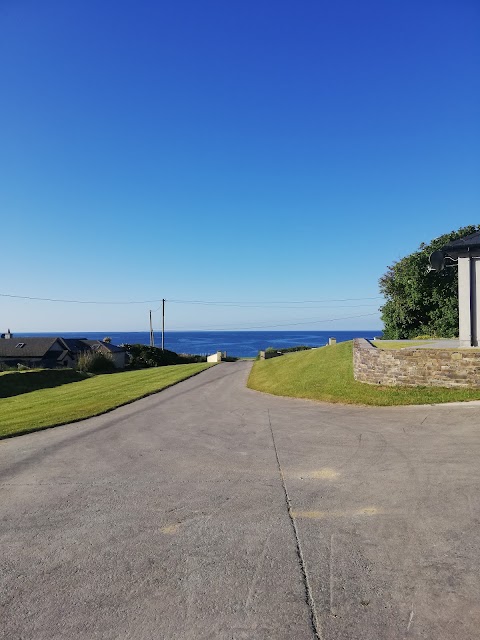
[248,342,480,406]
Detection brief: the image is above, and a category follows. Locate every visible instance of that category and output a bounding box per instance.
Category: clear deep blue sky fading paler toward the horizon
[0,0,480,333]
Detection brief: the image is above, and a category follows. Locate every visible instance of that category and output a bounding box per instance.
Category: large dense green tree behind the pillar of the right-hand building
[379,225,480,340]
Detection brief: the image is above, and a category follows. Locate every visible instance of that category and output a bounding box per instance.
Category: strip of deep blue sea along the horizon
[23,329,381,357]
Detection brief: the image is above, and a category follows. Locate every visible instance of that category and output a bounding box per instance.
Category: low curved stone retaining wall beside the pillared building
[353,338,480,387]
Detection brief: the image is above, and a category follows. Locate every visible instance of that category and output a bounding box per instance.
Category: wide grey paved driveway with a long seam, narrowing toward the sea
[0,362,480,640]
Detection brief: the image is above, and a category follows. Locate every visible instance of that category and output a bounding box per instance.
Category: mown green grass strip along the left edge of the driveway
[0,363,211,438]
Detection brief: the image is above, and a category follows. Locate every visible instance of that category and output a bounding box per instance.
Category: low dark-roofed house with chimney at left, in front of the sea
[0,336,127,369]
